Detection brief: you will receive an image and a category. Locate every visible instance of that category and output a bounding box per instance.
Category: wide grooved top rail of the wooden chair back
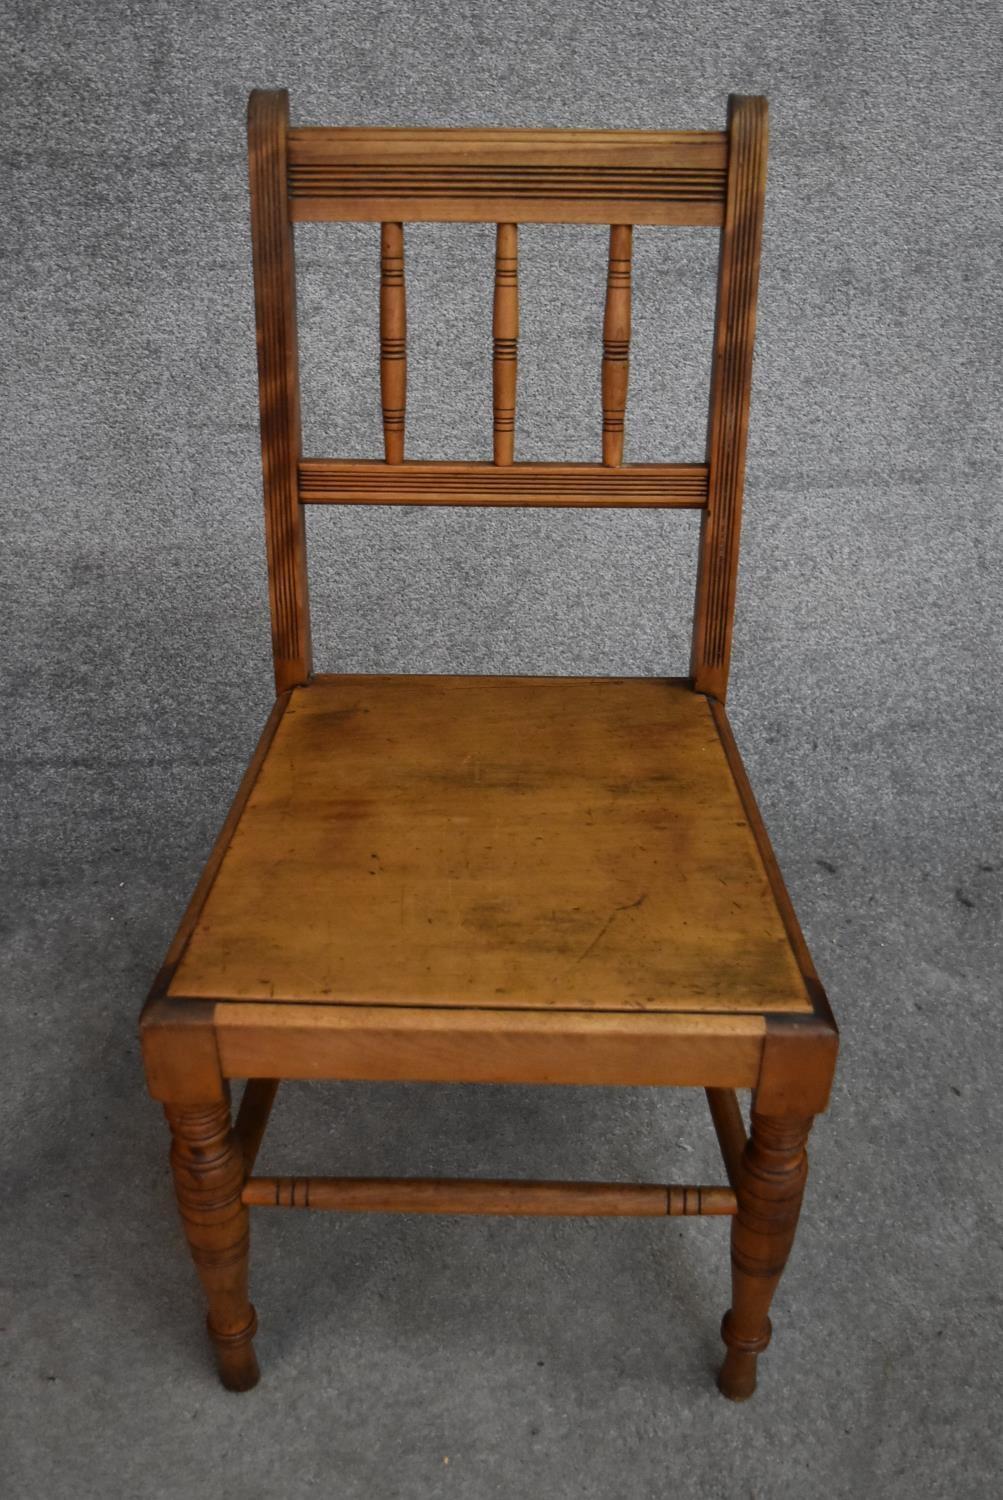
[288,128,726,225]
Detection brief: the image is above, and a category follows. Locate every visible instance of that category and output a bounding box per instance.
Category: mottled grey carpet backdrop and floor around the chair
[0,0,1003,1500]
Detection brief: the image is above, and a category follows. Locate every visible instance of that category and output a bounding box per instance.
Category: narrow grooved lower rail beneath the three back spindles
[293,459,708,510]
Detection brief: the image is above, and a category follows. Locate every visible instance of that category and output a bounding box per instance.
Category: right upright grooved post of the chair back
[691,95,766,699]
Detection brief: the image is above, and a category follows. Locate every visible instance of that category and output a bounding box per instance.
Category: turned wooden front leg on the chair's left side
[165,1103,258,1391]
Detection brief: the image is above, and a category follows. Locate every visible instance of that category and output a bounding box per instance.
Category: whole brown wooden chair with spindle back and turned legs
[141,92,837,1400]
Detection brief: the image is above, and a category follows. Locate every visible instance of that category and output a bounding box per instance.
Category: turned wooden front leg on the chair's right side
[718,1112,811,1401]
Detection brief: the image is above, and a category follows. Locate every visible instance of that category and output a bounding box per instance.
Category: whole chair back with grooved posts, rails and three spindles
[247,90,766,699]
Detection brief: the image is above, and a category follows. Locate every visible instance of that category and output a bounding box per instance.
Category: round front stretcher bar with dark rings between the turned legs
[243,1178,736,1218]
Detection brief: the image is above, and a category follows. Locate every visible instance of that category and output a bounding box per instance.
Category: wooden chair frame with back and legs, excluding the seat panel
[134,90,837,1400]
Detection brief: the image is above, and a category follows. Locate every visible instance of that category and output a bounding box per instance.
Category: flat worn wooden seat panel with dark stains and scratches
[169,677,811,1013]
